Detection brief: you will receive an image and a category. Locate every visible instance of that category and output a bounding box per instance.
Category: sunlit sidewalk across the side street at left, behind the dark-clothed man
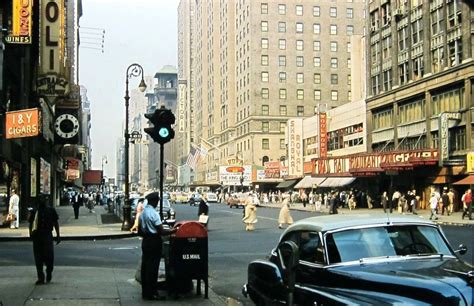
[0,206,133,241]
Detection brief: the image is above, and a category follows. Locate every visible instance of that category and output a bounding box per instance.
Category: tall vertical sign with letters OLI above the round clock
[36,0,69,104]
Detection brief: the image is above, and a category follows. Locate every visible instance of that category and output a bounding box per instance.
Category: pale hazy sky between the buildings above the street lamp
[79,0,179,178]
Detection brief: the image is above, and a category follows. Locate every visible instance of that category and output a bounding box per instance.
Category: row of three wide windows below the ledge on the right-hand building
[372,88,466,130]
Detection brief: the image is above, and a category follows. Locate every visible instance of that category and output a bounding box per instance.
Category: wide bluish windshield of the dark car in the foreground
[326,225,453,264]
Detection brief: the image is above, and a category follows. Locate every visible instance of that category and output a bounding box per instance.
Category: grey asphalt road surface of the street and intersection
[0,204,474,305]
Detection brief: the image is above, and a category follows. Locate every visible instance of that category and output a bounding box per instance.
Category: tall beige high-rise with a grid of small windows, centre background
[178,0,365,184]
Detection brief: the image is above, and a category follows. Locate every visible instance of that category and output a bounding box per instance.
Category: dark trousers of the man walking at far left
[33,232,54,280]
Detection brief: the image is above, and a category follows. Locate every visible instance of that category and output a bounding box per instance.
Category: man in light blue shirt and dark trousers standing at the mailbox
[138,192,176,300]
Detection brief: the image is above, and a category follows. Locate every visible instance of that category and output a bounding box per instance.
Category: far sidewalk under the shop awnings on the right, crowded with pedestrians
[260,203,474,227]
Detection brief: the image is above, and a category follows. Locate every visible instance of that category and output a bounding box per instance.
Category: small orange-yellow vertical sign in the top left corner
[5,0,33,44]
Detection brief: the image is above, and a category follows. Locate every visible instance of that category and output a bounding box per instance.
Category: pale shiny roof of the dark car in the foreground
[285,213,434,233]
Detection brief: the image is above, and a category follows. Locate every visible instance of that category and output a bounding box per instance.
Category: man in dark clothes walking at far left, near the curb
[28,195,61,285]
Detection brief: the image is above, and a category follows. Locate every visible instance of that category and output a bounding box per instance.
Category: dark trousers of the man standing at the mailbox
[141,235,161,298]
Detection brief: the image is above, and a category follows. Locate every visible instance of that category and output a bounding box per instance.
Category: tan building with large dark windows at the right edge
[367,0,474,175]
